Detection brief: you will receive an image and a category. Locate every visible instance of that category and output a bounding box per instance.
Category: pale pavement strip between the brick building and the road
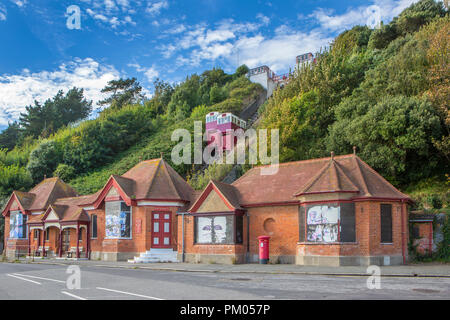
[7,259,450,278]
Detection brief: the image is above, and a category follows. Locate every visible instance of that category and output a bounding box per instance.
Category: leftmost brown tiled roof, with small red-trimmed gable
[3,177,77,215]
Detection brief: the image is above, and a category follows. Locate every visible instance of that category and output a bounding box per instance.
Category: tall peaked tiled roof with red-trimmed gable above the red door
[85,159,195,206]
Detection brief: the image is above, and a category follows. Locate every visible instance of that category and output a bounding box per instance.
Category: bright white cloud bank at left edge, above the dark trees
[0,58,120,125]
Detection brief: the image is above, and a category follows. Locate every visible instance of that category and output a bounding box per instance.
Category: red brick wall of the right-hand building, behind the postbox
[178,201,408,257]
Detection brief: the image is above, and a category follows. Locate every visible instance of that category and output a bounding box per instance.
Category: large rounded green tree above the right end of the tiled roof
[327,96,441,183]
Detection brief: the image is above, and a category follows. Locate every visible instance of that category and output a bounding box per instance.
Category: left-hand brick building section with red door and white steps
[3,159,194,260]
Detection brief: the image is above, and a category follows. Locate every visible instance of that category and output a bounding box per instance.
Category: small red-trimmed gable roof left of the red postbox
[188,180,242,212]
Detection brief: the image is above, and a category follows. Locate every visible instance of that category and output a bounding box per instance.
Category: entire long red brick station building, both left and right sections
[2,154,410,266]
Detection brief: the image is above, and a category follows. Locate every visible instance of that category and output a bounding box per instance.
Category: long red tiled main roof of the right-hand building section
[232,155,409,206]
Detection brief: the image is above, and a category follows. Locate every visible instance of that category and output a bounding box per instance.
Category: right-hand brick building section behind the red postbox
[178,154,410,266]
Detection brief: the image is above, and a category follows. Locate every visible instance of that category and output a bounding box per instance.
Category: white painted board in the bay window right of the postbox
[307,205,340,242]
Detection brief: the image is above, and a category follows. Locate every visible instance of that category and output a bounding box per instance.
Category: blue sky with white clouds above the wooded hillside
[0,0,415,130]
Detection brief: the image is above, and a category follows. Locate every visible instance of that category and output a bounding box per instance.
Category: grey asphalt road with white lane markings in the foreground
[0,263,450,300]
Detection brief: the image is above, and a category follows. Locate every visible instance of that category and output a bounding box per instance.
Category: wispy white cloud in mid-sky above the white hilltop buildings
[159,18,332,72]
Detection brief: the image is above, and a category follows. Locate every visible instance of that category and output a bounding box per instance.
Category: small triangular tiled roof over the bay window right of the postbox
[295,159,359,196]
